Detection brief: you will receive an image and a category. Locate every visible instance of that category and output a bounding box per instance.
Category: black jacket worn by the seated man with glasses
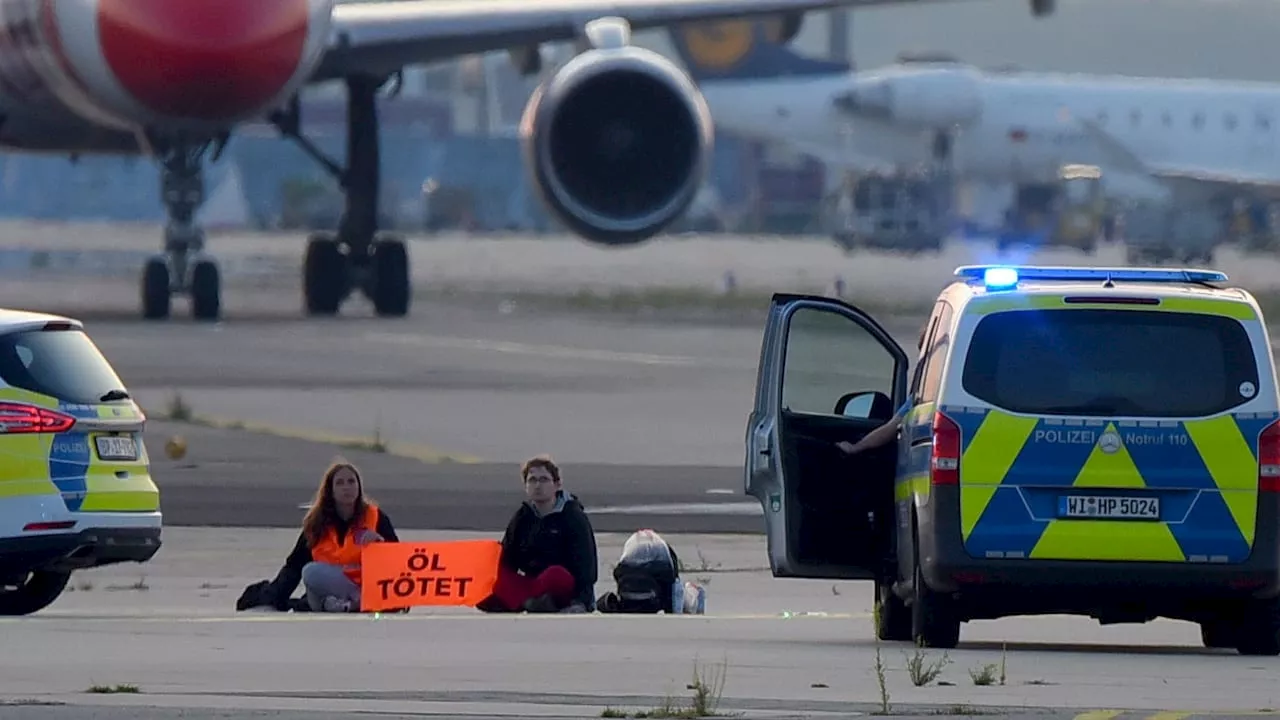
[499,491,599,610]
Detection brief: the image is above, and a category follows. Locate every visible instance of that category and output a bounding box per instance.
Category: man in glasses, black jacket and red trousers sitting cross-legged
[476,455,599,612]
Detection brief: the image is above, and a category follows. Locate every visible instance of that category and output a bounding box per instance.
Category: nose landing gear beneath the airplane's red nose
[142,141,221,320]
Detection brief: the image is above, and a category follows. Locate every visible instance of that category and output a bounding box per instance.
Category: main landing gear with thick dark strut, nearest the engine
[271,76,412,316]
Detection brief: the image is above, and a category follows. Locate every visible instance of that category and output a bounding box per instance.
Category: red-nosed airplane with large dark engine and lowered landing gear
[0,0,1052,320]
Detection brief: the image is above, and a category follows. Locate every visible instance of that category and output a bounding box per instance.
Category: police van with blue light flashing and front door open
[745,266,1280,655]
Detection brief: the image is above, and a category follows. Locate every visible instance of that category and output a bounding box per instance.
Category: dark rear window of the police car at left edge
[0,331,124,405]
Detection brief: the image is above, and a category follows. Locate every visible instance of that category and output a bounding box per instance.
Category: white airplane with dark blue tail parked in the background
[668,19,1280,254]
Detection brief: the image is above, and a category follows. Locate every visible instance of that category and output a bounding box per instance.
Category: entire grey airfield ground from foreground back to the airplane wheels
[0,228,1280,720]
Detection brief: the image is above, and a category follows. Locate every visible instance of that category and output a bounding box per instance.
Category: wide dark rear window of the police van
[961,310,1258,418]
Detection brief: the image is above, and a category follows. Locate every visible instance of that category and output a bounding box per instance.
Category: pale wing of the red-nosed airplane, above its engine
[310,0,957,82]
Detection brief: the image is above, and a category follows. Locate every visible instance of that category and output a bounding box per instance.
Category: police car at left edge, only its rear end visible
[0,310,161,615]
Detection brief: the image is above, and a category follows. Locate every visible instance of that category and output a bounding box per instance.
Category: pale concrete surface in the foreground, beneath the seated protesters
[0,528,1280,719]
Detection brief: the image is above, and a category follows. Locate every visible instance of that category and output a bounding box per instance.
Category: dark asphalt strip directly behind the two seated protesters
[147,421,764,533]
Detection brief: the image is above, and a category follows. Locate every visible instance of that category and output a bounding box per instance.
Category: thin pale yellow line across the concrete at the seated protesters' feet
[0,611,872,625]
